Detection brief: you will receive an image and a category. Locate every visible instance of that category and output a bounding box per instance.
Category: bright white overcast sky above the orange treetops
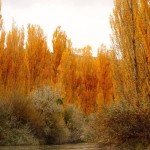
[2,0,113,55]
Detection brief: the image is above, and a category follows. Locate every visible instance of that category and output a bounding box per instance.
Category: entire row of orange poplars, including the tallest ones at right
[0,0,150,113]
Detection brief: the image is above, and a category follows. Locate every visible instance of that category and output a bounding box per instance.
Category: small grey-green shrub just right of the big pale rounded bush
[64,105,85,142]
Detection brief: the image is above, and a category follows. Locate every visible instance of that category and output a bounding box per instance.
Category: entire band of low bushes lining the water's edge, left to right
[0,87,150,149]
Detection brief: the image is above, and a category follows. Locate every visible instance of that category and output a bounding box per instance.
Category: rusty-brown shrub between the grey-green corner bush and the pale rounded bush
[4,91,43,138]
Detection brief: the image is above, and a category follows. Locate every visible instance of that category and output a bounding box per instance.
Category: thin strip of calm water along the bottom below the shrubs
[0,143,100,150]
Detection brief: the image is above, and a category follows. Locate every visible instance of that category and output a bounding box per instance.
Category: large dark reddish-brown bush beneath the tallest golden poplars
[85,103,150,149]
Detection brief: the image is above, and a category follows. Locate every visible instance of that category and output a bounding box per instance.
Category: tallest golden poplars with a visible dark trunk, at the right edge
[111,0,150,105]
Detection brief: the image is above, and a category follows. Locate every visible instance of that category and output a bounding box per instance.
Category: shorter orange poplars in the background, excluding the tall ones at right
[0,24,113,113]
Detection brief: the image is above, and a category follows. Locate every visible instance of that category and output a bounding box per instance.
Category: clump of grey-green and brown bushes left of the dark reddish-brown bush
[0,87,85,145]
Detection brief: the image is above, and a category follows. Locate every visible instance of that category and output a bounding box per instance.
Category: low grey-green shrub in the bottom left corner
[0,100,38,145]
